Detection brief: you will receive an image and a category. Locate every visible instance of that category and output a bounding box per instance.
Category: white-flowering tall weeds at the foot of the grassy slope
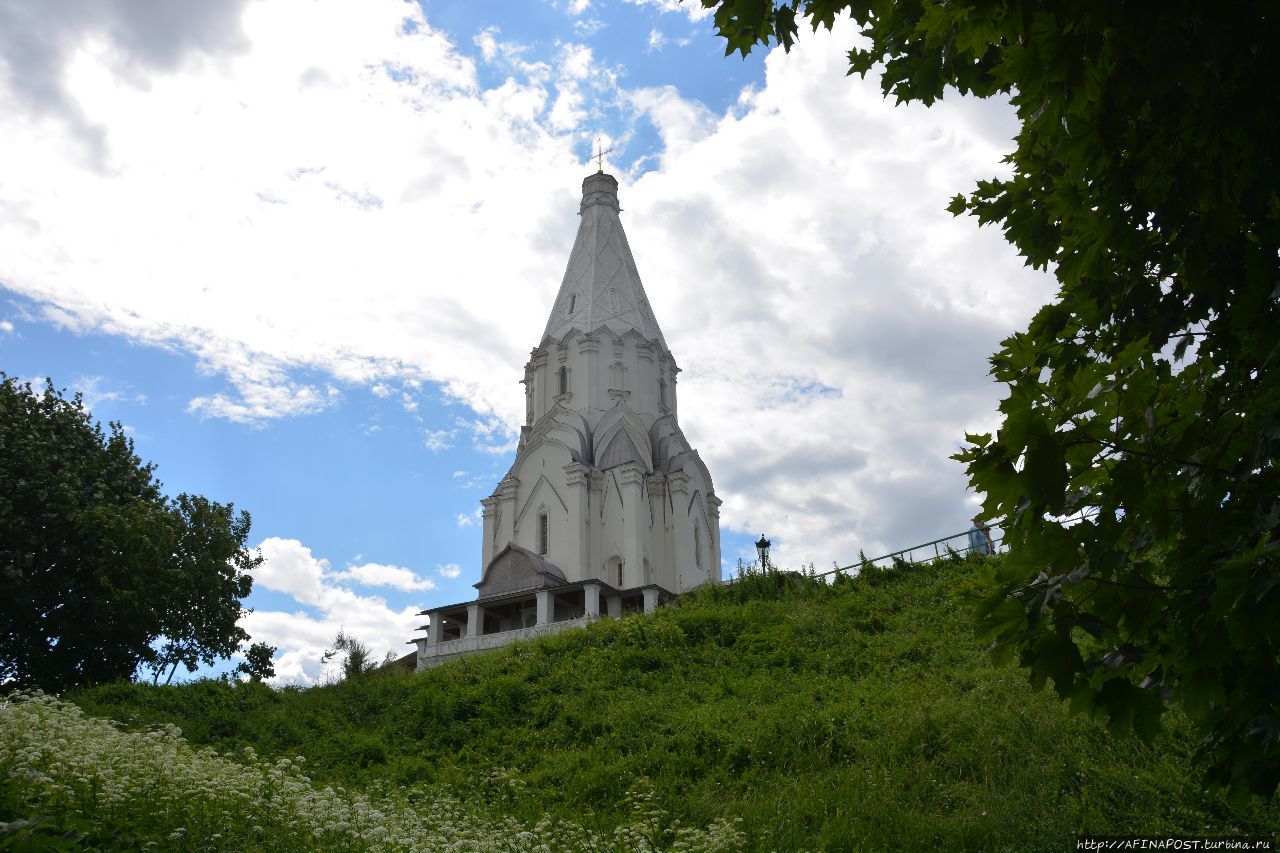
[0,693,744,850]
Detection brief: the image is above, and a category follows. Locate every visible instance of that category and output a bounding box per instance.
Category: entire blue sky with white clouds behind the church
[0,0,1052,683]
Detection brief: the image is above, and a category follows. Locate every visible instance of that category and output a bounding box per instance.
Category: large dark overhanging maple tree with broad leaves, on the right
[703,0,1280,793]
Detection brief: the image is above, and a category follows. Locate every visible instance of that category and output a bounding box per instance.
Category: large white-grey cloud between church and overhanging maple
[623,18,1052,558]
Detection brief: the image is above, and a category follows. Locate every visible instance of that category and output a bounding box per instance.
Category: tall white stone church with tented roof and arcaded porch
[413,172,721,670]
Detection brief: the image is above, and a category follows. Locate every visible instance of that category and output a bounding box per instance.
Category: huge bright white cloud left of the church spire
[0,0,581,421]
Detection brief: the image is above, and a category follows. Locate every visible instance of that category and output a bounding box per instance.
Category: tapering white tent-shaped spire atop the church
[543,172,667,350]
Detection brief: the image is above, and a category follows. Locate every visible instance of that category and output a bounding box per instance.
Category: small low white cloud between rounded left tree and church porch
[248,537,424,684]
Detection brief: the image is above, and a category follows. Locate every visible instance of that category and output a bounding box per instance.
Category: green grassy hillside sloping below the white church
[70,562,1280,850]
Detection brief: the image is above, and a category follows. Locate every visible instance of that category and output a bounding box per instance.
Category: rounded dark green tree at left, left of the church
[0,373,261,690]
